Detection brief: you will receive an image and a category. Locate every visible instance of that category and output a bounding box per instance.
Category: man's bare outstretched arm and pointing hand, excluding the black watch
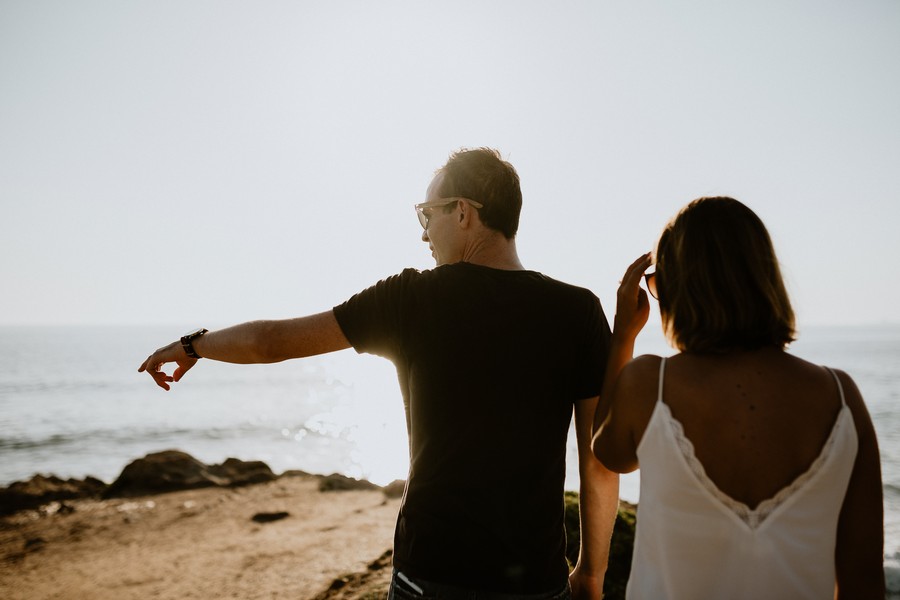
[138,310,350,390]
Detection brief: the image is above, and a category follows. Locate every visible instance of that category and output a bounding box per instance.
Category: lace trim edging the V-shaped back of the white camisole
[659,356,847,529]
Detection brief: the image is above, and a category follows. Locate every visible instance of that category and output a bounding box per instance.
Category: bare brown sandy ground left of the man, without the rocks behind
[0,476,400,600]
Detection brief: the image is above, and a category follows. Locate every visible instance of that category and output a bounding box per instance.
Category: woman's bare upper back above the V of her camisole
[663,349,841,508]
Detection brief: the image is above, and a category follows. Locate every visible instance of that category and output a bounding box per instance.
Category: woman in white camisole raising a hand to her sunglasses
[593,198,885,600]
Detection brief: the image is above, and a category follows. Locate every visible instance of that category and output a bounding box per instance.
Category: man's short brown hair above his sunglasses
[438,148,522,239]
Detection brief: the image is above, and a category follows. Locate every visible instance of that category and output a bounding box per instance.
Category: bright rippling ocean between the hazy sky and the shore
[0,324,900,594]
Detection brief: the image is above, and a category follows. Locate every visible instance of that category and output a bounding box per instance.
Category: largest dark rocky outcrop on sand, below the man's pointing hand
[103,450,277,498]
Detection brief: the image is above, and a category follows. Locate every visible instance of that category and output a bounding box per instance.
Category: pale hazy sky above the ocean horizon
[0,0,900,334]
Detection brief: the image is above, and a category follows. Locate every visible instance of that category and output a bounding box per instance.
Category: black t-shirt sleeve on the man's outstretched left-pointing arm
[333,269,418,358]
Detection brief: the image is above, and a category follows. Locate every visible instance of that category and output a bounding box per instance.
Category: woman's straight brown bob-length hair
[656,197,795,354]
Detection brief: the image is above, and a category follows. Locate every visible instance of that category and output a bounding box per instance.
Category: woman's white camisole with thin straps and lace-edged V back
[626,358,857,600]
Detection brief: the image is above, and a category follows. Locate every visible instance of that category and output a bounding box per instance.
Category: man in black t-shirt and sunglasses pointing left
[140,149,618,599]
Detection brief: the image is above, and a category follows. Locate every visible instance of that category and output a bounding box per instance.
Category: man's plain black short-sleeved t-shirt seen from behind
[334,263,610,593]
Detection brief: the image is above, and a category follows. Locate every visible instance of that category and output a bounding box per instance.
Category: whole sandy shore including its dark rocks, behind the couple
[0,450,635,600]
